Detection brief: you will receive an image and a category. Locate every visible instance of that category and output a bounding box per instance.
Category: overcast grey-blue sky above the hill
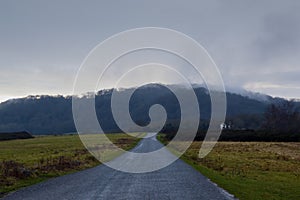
[0,0,300,101]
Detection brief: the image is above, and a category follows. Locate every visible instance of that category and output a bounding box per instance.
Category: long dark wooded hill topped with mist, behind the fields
[0,84,299,134]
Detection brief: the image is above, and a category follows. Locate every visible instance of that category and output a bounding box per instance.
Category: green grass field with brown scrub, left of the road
[0,134,139,196]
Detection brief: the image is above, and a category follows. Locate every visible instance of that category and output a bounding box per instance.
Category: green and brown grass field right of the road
[161,135,300,200]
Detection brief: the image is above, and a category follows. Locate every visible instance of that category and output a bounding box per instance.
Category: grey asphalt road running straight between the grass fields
[3,136,233,200]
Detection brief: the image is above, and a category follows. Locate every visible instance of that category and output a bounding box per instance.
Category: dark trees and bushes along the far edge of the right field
[161,101,300,142]
